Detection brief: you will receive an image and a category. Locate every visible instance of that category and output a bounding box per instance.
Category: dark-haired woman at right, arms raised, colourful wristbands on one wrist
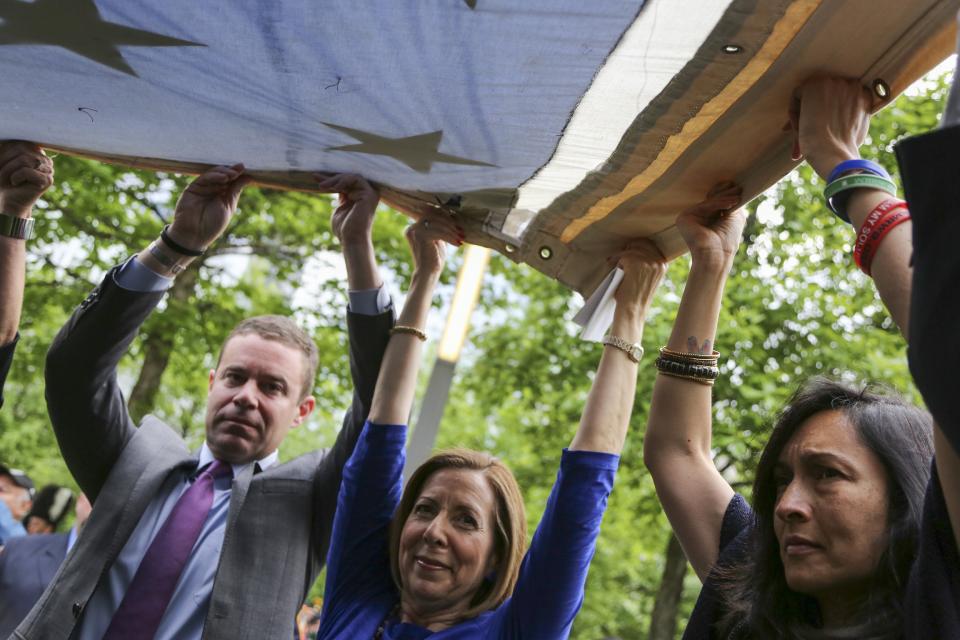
[644,78,960,640]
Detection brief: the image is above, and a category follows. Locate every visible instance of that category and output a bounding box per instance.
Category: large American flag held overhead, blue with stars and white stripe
[0,0,960,293]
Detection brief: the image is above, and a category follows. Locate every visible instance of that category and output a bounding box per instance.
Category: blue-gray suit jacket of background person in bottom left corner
[0,533,69,638]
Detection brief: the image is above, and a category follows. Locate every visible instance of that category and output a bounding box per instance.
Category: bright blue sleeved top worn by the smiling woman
[317,422,620,640]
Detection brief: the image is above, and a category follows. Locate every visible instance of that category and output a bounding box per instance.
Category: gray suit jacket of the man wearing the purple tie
[11,272,393,640]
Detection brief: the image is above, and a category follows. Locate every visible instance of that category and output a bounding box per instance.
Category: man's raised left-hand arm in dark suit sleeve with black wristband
[46,165,249,502]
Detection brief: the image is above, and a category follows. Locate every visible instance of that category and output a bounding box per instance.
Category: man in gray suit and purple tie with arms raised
[12,165,393,640]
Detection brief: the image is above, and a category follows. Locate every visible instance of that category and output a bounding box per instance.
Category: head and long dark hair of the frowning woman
[717,378,933,638]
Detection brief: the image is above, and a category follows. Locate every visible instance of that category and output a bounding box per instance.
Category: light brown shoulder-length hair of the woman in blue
[390,449,527,619]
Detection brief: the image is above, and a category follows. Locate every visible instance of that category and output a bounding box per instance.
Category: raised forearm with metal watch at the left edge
[0,141,53,407]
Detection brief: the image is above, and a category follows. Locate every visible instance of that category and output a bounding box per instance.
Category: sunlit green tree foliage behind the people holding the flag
[0,74,946,640]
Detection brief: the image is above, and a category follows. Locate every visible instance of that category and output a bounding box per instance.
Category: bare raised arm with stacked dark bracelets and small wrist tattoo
[643,184,744,580]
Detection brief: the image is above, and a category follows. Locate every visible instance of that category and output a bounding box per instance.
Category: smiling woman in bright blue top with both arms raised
[317,216,666,640]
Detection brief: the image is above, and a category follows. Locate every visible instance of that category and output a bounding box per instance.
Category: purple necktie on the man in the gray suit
[103,460,233,640]
